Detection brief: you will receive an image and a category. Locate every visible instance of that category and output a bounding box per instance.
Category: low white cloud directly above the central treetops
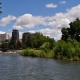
[29,28,61,40]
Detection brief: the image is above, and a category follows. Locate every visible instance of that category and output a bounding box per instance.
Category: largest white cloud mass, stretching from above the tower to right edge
[14,5,80,40]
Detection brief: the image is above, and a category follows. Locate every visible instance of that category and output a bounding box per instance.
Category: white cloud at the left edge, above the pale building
[0,15,16,26]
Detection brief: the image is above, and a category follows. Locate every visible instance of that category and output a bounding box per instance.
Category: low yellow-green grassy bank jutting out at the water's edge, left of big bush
[20,48,54,58]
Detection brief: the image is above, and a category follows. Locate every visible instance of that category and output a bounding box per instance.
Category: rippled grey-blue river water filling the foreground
[0,53,80,80]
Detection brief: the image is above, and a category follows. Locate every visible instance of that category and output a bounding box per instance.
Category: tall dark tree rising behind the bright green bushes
[61,18,80,41]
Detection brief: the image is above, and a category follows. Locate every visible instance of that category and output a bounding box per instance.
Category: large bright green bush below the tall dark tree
[54,38,80,60]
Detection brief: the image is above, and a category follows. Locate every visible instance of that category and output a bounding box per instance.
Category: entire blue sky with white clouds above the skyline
[0,0,80,40]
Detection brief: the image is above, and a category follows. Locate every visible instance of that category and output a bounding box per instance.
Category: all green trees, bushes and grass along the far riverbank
[1,18,80,60]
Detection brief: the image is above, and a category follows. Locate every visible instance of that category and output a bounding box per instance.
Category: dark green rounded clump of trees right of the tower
[22,32,54,48]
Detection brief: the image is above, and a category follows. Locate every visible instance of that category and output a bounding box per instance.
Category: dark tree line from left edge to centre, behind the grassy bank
[1,32,55,52]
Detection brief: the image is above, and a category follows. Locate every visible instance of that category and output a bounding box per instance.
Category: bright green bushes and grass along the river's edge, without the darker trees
[20,38,80,60]
